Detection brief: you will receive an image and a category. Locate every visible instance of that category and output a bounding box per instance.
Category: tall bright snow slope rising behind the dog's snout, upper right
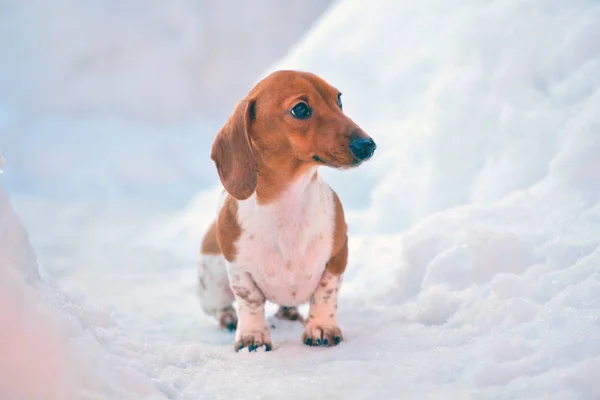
[274,0,600,233]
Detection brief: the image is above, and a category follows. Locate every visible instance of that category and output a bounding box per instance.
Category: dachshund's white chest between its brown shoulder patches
[235,176,335,306]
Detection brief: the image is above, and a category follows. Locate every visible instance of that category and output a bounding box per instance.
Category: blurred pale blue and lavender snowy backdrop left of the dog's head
[0,0,330,206]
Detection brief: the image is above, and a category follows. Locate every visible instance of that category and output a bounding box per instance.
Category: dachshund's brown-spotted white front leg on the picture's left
[228,264,273,351]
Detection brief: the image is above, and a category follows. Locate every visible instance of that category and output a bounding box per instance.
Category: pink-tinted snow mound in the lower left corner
[0,188,173,400]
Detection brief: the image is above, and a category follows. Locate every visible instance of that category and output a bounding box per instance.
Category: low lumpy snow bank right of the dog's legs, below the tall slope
[345,185,600,399]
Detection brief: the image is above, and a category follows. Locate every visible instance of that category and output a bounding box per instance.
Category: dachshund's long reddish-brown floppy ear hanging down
[210,100,256,200]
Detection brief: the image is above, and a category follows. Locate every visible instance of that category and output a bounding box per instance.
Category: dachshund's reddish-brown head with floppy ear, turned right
[211,71,376,200]
